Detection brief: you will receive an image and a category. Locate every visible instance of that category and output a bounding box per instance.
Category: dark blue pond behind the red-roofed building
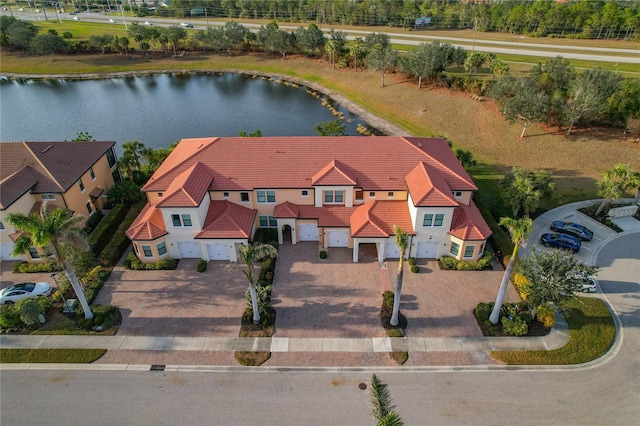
[0,73,366,152]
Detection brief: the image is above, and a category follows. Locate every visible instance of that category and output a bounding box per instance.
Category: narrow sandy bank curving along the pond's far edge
[0,69,409,136]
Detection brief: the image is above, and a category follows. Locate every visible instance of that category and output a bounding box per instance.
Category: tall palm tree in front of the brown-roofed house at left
[7,203,93,319]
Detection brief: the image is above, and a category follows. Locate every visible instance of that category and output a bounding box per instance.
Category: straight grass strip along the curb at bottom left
[0,349,106,364]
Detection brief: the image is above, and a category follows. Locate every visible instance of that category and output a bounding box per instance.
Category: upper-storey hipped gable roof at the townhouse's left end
[157,162,213,207]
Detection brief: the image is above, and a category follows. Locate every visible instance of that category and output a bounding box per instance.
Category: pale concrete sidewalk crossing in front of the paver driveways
[0,315,569,352]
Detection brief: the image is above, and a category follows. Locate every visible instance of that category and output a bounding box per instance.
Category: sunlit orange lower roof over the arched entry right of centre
[350,201,415,238]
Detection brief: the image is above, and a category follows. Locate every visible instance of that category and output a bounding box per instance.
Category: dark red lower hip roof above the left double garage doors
[195,200,257,239]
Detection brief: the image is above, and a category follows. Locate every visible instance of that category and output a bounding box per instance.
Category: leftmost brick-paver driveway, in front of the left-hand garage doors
[95,259,247,337]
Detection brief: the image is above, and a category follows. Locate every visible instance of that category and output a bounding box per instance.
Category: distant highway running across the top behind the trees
[2,9,640,65]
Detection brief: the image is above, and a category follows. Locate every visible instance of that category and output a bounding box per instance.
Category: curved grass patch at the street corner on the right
[491,297,616,365]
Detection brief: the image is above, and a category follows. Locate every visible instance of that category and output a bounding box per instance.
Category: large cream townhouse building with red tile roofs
[127,136,491,262]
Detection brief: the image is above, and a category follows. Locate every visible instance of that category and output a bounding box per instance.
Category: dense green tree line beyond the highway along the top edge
[155,0,640,39]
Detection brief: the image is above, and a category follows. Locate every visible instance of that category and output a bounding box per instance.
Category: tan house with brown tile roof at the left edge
[0,141,119,262]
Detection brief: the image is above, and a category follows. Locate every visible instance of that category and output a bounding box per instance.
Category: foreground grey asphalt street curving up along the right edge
[0,232,640,425]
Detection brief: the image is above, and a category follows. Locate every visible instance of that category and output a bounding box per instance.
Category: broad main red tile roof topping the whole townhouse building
[143,136,477,198]
